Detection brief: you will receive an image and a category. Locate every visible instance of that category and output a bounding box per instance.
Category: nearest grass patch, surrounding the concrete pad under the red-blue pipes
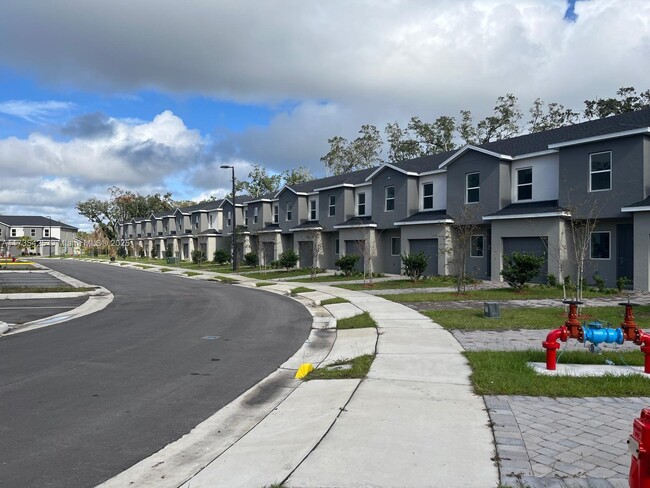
[464,351,650,397]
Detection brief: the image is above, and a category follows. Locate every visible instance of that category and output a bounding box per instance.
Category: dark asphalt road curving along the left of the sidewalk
[0,261,311,488]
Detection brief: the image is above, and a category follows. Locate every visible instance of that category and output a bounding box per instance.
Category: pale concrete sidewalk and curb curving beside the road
[93,264,499,488]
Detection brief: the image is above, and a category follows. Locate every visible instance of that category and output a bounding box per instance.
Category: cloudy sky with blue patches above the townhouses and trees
[0,0,650,230]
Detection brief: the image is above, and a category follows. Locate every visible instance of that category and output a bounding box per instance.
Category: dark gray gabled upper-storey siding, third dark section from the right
[372,168,409,229]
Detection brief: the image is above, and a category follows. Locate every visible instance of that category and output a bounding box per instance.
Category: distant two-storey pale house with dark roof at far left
[0,215,80,256]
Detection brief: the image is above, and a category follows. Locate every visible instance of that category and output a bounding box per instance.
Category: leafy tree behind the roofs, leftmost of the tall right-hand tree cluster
[320,125,383,175]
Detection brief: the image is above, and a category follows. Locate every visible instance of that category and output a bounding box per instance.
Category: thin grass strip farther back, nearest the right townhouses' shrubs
[380,285,616,303]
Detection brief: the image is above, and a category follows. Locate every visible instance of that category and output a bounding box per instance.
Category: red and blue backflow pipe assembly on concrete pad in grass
[542,301,650,374]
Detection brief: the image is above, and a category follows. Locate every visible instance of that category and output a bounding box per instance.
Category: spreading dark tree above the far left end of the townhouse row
[75,186,174,240]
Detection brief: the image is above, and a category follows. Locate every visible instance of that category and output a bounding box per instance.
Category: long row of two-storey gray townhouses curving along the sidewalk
[120,110,650,290]
